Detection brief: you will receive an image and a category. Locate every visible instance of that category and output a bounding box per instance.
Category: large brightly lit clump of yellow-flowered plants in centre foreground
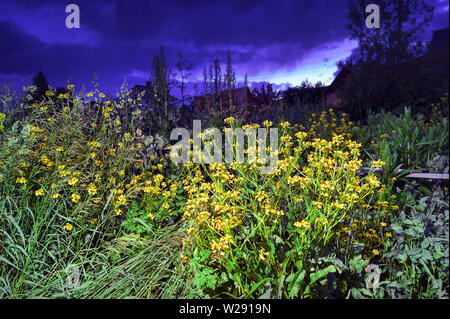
[183,116,392,298]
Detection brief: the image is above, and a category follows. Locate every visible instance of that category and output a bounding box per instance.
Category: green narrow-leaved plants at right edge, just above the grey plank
[353,96,449,183]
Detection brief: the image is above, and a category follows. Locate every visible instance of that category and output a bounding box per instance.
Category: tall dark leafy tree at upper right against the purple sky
[337,0,433,121]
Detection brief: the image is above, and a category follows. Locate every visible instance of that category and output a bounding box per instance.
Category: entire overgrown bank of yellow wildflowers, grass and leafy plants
[0,84,449,298]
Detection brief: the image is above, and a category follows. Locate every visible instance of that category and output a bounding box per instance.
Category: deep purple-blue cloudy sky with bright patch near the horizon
[0,0,449,93]
